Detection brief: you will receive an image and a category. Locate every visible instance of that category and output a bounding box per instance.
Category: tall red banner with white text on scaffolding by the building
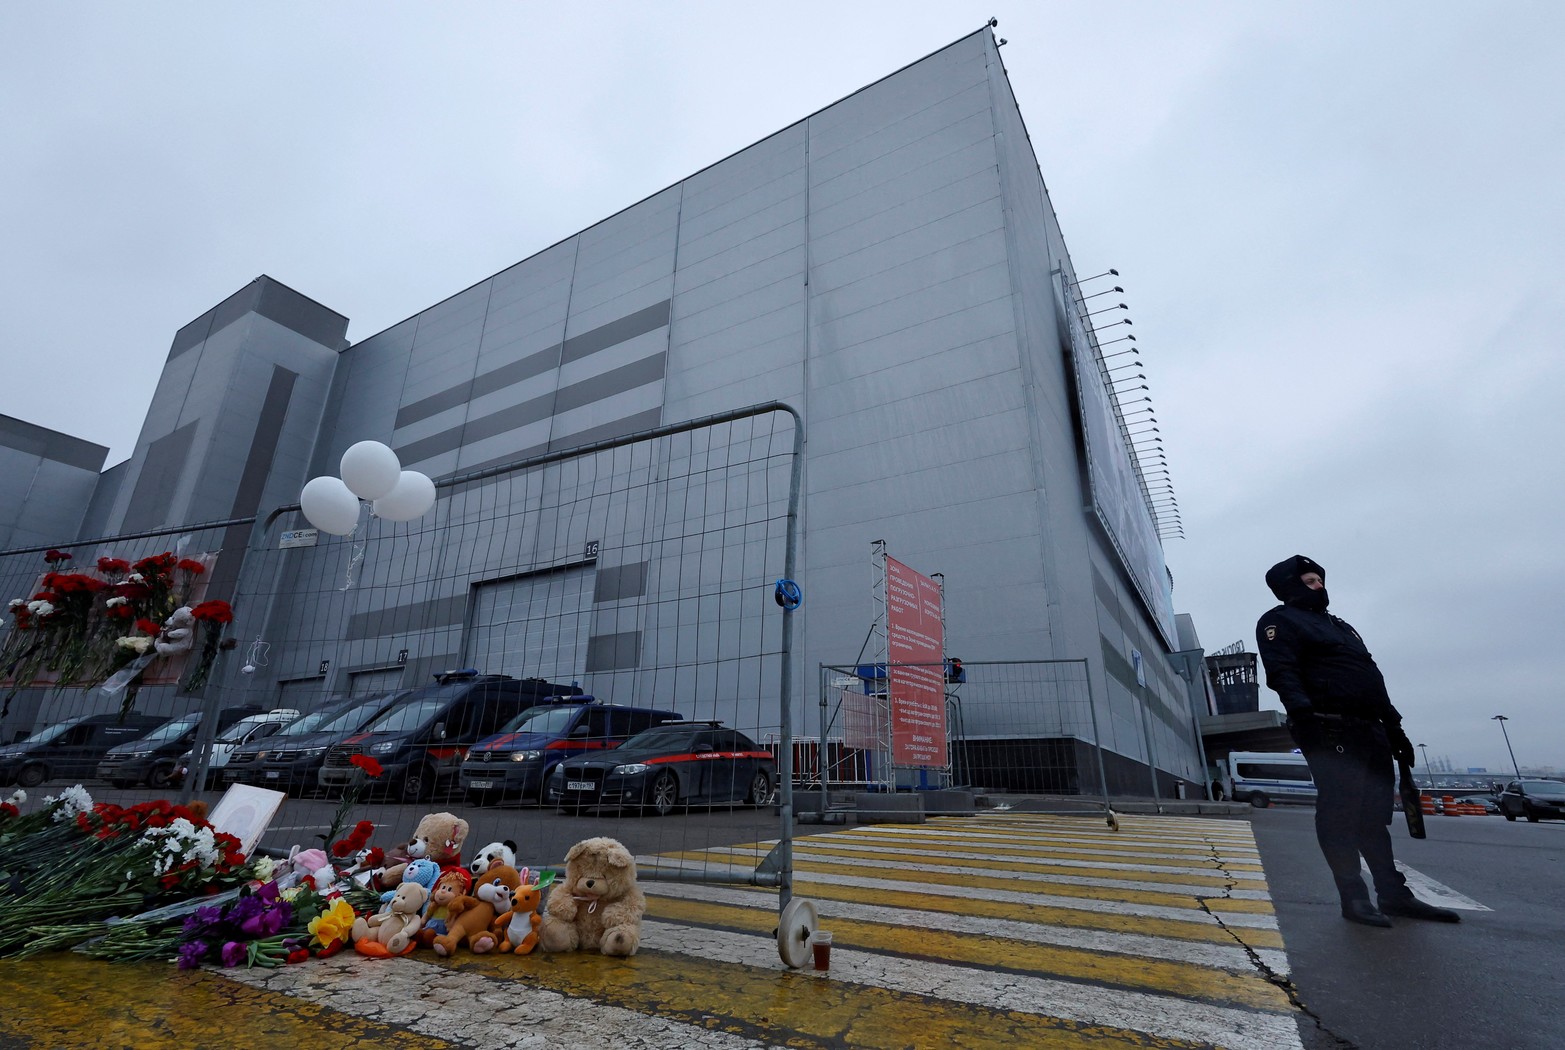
[886,557,948,767]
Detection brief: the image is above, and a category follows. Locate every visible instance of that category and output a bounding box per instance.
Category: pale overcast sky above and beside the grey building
[0,0,1565,770]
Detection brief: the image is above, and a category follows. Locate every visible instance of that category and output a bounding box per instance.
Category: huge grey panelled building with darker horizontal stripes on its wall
[0,30,1207,784]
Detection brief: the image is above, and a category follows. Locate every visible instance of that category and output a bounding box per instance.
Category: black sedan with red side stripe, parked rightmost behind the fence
[545,721,778,817]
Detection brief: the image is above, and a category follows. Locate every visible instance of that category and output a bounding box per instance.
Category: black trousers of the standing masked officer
[1299,726,1412,904]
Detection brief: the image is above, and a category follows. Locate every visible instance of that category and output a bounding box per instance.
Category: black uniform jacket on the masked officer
[1255,606,1402,726]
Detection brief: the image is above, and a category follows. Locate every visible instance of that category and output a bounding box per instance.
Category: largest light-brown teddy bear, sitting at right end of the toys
[538,839,646,956]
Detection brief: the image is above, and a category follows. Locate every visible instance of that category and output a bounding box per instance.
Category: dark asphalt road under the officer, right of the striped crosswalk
[1252,806,1565,1050]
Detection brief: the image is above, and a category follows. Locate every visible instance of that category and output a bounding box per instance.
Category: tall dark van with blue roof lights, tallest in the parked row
[321,668,582,803]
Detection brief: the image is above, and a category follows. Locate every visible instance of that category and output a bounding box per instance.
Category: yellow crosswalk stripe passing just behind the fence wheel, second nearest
[646,897,1291,1012]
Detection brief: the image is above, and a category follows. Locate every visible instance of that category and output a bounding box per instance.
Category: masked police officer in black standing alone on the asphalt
[1255,554,1462,926]
